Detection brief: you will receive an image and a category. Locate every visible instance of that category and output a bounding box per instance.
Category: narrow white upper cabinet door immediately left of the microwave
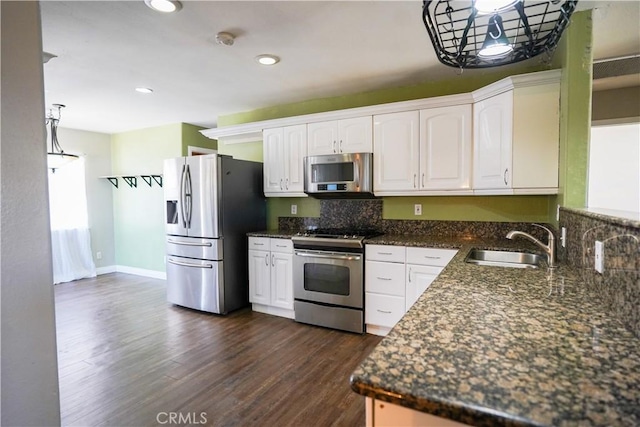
[283,125,307,193]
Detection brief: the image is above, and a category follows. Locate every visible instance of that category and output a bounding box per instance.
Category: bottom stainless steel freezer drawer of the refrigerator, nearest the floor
[167,255,226,314]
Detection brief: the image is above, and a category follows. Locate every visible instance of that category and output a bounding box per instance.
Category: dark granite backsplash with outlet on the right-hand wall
[560,208,640,337]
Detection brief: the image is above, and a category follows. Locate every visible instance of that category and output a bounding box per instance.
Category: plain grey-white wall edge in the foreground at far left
[0,1,60,426]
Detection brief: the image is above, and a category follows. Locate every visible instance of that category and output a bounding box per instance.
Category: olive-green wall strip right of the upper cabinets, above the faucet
[554,10,593,211]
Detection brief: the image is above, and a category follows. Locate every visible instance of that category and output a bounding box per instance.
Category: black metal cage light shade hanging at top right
[422,0,578,69]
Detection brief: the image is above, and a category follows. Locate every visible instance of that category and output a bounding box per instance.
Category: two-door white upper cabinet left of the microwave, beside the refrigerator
[262,125,307,197]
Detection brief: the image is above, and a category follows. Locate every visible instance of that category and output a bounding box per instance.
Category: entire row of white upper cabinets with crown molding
[203,70,561,196]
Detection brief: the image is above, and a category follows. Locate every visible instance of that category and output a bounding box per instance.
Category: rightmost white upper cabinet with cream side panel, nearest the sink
[473,70,560,194]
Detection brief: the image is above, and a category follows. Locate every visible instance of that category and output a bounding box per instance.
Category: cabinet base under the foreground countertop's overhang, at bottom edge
[365,397,467,427]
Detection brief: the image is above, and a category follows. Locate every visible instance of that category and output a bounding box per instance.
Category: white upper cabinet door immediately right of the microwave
[373,111,420,194]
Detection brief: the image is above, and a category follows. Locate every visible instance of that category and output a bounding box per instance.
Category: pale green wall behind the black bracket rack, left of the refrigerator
[111,123,182,272]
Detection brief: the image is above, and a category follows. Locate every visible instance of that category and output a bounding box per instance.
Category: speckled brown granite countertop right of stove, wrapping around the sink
[351,235,640,426]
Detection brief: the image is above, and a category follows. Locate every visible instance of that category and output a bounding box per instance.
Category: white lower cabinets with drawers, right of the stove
[364,245,458,335]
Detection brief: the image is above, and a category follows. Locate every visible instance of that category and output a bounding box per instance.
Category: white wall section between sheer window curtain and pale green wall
[58,129,118,273]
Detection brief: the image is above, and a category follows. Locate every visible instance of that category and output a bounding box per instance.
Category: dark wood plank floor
[55,273,380,426]
